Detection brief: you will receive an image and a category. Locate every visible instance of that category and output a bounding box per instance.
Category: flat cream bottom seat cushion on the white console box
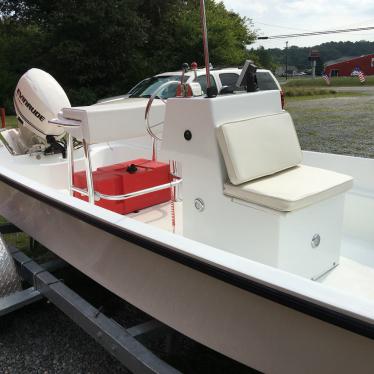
[224,165,353,212]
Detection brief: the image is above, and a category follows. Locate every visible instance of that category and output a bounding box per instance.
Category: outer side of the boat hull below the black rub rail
[0,176,374,373]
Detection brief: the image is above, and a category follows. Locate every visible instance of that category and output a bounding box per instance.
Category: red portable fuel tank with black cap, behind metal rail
[74,159,171,214]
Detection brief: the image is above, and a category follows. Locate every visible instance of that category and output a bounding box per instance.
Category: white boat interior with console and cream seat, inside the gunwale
[1,87,374,302]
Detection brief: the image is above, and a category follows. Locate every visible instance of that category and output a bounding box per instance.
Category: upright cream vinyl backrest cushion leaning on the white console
[217,112,302,185]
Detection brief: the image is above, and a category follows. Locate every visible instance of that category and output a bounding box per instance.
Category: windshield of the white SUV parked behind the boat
[130,75,189,99]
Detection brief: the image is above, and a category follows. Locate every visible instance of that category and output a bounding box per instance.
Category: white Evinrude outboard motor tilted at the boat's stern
[13,69,71,155]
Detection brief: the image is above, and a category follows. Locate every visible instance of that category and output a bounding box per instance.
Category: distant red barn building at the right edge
[325,54,374,77]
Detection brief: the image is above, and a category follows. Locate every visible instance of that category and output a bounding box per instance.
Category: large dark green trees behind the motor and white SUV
[0,0,255,111]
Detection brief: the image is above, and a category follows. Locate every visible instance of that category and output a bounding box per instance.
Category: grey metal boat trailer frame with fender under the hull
[0,224,180,374]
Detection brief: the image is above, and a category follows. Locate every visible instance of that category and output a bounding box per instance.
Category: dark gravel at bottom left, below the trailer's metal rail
[0,302,129,374]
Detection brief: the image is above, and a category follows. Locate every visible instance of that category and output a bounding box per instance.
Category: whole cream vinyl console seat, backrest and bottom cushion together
[217,111,353,212]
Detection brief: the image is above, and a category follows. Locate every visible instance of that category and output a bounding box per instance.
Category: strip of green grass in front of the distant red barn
[281,76,374,88]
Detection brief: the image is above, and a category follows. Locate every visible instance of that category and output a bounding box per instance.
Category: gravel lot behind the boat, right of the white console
[286,87,374,157]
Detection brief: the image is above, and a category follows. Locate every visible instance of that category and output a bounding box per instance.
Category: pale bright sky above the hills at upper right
[222,0,374,48]
